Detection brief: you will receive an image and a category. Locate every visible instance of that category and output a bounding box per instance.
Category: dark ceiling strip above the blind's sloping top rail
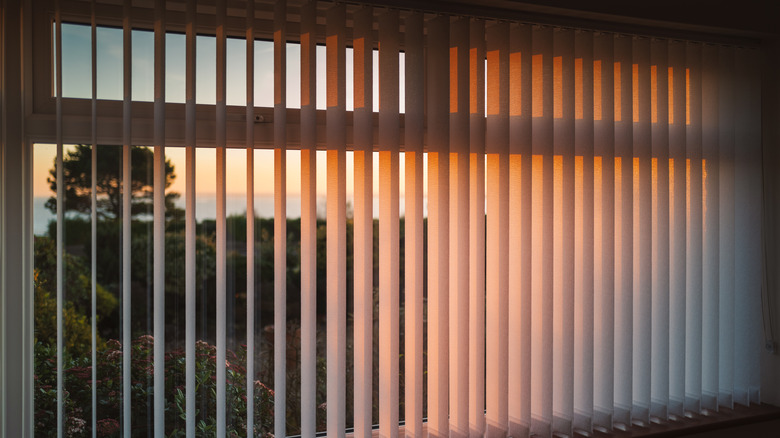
[362,0,780,44]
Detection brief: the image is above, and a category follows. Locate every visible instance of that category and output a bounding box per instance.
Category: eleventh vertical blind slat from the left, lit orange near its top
[353,6,374,437]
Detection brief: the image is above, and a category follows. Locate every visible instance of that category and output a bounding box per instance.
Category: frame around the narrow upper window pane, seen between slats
[26,0,404,151]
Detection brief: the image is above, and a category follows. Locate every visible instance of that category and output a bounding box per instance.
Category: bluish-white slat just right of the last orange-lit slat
[718,47,736,409]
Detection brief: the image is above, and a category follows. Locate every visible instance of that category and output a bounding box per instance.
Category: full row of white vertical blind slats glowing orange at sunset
[44,0,762,437]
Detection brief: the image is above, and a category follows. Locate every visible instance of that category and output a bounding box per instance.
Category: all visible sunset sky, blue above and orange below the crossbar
[42,23,418,202]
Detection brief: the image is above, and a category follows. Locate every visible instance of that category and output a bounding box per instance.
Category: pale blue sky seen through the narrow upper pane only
[62,24,405,113]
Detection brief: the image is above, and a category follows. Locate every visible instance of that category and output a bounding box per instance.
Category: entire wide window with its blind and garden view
[4,0,771,436]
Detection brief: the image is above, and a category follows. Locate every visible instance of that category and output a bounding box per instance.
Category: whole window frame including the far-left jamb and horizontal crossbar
[0,0,771,435]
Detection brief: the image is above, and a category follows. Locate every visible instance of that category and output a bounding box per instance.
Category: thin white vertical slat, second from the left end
[90,0,97,438]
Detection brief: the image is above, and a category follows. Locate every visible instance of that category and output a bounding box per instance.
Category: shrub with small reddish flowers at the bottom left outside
[34,335,274,437]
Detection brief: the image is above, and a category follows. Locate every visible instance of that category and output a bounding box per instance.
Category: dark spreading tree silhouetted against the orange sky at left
[46,144,181,220]
